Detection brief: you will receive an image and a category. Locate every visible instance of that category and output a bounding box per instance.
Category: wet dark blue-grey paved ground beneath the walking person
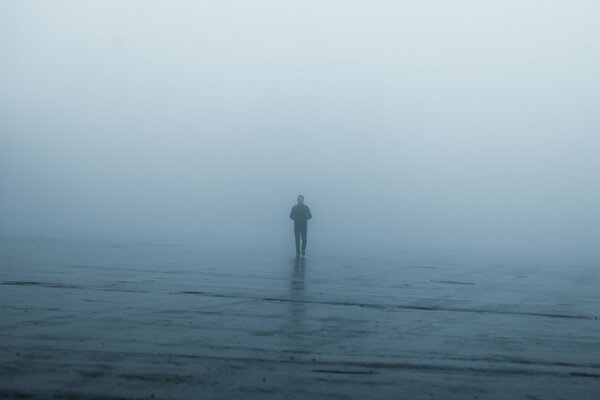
[0,238,600,400]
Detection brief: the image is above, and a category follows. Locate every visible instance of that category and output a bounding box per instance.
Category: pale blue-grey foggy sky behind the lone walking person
[0,0,600,257]
